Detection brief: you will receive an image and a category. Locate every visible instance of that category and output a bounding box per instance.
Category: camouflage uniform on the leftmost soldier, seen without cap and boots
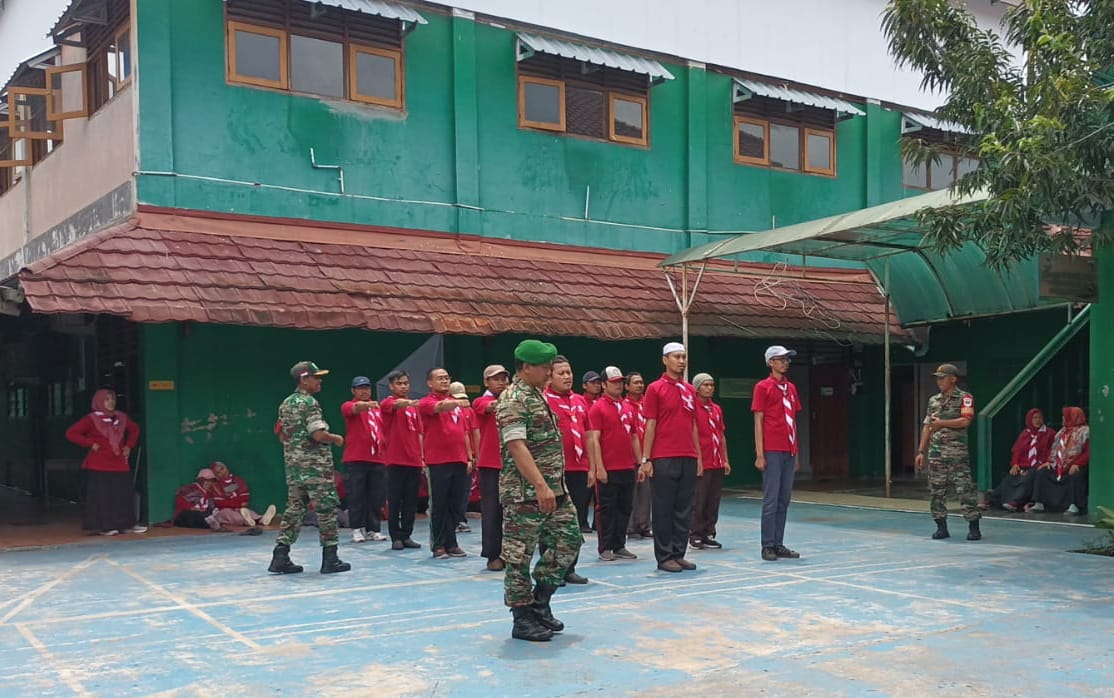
[276,390,340,548]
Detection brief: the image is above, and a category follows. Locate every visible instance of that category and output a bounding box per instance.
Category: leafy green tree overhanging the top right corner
[882,0,1114,265]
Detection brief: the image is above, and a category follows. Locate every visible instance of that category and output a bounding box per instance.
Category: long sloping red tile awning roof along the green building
[19,209,896,344]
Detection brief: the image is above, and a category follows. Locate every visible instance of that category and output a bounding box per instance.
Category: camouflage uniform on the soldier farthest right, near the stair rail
[925,387,981,521]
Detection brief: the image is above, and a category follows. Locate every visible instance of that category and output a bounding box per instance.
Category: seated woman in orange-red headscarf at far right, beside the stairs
[1025,407,1091,514]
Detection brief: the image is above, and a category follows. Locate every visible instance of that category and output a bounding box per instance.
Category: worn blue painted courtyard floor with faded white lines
[0,498,1114,698]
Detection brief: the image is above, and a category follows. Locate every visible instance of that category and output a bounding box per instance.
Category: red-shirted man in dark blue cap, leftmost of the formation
[341,375,387,543]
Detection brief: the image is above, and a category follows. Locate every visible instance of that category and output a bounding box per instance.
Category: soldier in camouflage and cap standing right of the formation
[916,364,983,540]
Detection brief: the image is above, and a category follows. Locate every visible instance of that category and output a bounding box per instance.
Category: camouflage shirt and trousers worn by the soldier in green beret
[496,376,584,608]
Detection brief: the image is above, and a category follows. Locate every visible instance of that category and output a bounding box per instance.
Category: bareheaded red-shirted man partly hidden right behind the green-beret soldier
[546,354,596,584]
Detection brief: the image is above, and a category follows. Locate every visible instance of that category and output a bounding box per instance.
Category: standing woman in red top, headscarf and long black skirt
[66,389,147,535]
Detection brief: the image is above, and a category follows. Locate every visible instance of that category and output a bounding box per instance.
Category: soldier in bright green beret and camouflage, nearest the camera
[496,340,584,642]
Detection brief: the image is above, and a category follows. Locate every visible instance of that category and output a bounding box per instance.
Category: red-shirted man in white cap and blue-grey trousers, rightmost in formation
[751,345,801,562]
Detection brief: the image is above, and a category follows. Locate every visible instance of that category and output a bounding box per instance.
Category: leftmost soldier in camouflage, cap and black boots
[267,361,352,574]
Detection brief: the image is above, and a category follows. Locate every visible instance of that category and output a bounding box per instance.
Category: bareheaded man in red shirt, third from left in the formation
[418,367,472,560]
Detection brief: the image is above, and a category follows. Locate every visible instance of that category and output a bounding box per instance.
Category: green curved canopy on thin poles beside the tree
[662,185,1045,326]
